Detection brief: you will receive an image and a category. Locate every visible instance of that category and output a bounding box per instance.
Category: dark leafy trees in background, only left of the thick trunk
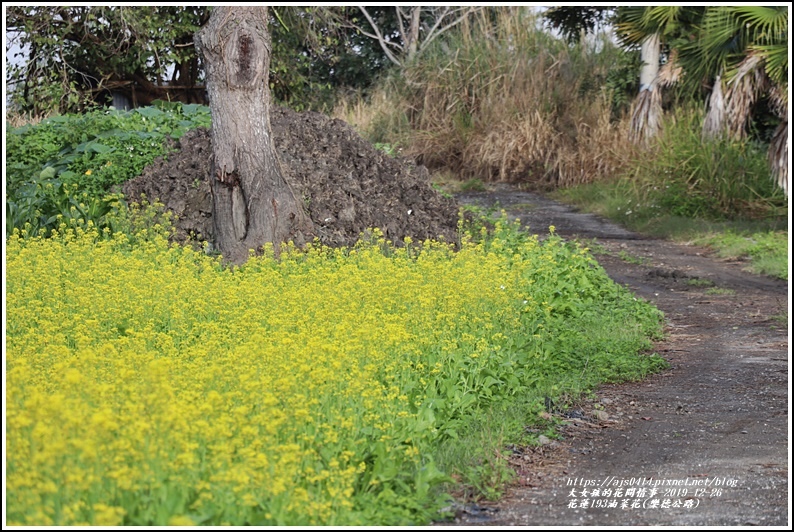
[6,6,209,114]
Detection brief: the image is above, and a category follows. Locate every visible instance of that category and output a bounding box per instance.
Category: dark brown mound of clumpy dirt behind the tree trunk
[123,106,458,251]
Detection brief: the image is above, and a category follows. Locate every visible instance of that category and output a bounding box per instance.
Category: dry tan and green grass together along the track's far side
[335,8,788,278]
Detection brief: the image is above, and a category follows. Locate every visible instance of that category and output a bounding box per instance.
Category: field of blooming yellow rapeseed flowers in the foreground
[6,219,664,525]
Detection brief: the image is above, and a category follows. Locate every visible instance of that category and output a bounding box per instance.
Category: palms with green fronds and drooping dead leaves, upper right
[617,6,788,195]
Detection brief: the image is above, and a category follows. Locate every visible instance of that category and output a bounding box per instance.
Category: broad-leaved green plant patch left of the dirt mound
[6,102,211,235]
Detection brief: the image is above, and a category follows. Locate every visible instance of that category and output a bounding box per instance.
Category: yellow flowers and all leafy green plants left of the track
[6,87,665,525]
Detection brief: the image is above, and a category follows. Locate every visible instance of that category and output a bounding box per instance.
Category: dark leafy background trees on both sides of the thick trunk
[6,6,394,115]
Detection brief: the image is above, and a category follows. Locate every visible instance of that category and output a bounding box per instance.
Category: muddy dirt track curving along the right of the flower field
[447,187,790,526]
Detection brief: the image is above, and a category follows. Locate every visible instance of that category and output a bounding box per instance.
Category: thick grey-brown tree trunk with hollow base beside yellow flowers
[195,6,311,264]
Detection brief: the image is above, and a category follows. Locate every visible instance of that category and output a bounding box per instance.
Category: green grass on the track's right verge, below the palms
[551,110,789,279]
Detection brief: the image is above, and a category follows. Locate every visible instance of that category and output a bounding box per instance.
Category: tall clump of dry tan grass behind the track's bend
[334,8,633,187]
